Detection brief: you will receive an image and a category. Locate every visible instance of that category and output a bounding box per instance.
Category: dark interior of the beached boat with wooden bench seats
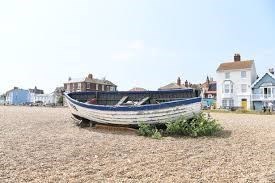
[68,89,200,106]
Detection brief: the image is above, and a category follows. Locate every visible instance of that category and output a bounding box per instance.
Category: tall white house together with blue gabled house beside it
[217,54,275,110]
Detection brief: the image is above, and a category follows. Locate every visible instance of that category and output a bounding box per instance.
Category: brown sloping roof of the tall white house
[217,60,254,71]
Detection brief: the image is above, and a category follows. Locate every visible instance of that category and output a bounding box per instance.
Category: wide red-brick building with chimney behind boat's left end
[64,74,117,92]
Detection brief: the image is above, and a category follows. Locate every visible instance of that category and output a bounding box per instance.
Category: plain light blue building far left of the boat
[6,87,30,105]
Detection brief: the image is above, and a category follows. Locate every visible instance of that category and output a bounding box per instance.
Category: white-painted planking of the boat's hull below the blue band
[66,96,201,125]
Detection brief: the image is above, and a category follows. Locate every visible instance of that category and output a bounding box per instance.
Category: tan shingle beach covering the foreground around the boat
[0,107,275,182]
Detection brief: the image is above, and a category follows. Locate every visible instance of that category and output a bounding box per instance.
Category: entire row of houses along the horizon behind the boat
[0,54,275,110]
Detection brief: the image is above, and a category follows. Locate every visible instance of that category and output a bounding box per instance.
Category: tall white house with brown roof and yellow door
[217,54,257,110]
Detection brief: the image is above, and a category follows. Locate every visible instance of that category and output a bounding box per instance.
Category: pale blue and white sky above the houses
[0,0,275,93]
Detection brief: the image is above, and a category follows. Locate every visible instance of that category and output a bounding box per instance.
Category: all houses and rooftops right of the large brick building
[125,54,275,110]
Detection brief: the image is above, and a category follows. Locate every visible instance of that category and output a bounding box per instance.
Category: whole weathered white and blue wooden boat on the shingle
[65,89,201,126]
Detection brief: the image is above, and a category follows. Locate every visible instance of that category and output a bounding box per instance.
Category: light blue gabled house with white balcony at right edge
[251,69,275,110]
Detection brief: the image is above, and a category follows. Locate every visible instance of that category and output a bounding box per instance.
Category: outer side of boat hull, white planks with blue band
[65,94,201,125]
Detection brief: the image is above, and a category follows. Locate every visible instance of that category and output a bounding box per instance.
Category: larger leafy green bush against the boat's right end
[166,113,222,137]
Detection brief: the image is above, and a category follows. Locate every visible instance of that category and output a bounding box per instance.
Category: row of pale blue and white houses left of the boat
[0,87,64,105]
